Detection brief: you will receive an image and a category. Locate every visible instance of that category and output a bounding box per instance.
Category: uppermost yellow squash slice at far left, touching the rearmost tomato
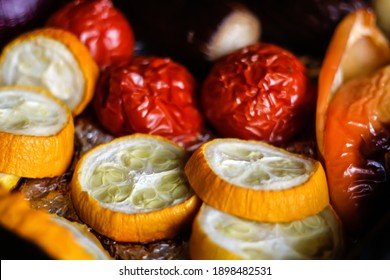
[0,28,99,116]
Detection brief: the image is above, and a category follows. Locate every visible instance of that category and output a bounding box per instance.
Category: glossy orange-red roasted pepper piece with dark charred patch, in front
[324,66,390,235]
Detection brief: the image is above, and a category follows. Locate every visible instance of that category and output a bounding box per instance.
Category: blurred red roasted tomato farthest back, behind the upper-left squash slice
[47,0,134,69]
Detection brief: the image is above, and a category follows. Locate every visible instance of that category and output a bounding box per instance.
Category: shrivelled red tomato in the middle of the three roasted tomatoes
[93,56,203,149]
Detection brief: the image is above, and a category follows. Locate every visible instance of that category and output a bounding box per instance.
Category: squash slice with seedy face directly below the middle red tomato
[71,134,200,242]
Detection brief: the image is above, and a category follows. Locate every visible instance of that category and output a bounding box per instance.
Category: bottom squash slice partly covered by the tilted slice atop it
[189,204,343,260]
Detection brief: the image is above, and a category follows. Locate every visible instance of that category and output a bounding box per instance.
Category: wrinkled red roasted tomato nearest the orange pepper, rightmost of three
[201,43,315,145]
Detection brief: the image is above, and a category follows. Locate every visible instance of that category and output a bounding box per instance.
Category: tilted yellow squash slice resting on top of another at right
[185,138,329,222]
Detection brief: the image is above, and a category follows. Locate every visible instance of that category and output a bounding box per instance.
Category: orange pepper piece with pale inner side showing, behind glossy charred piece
[316,9,390,161]
